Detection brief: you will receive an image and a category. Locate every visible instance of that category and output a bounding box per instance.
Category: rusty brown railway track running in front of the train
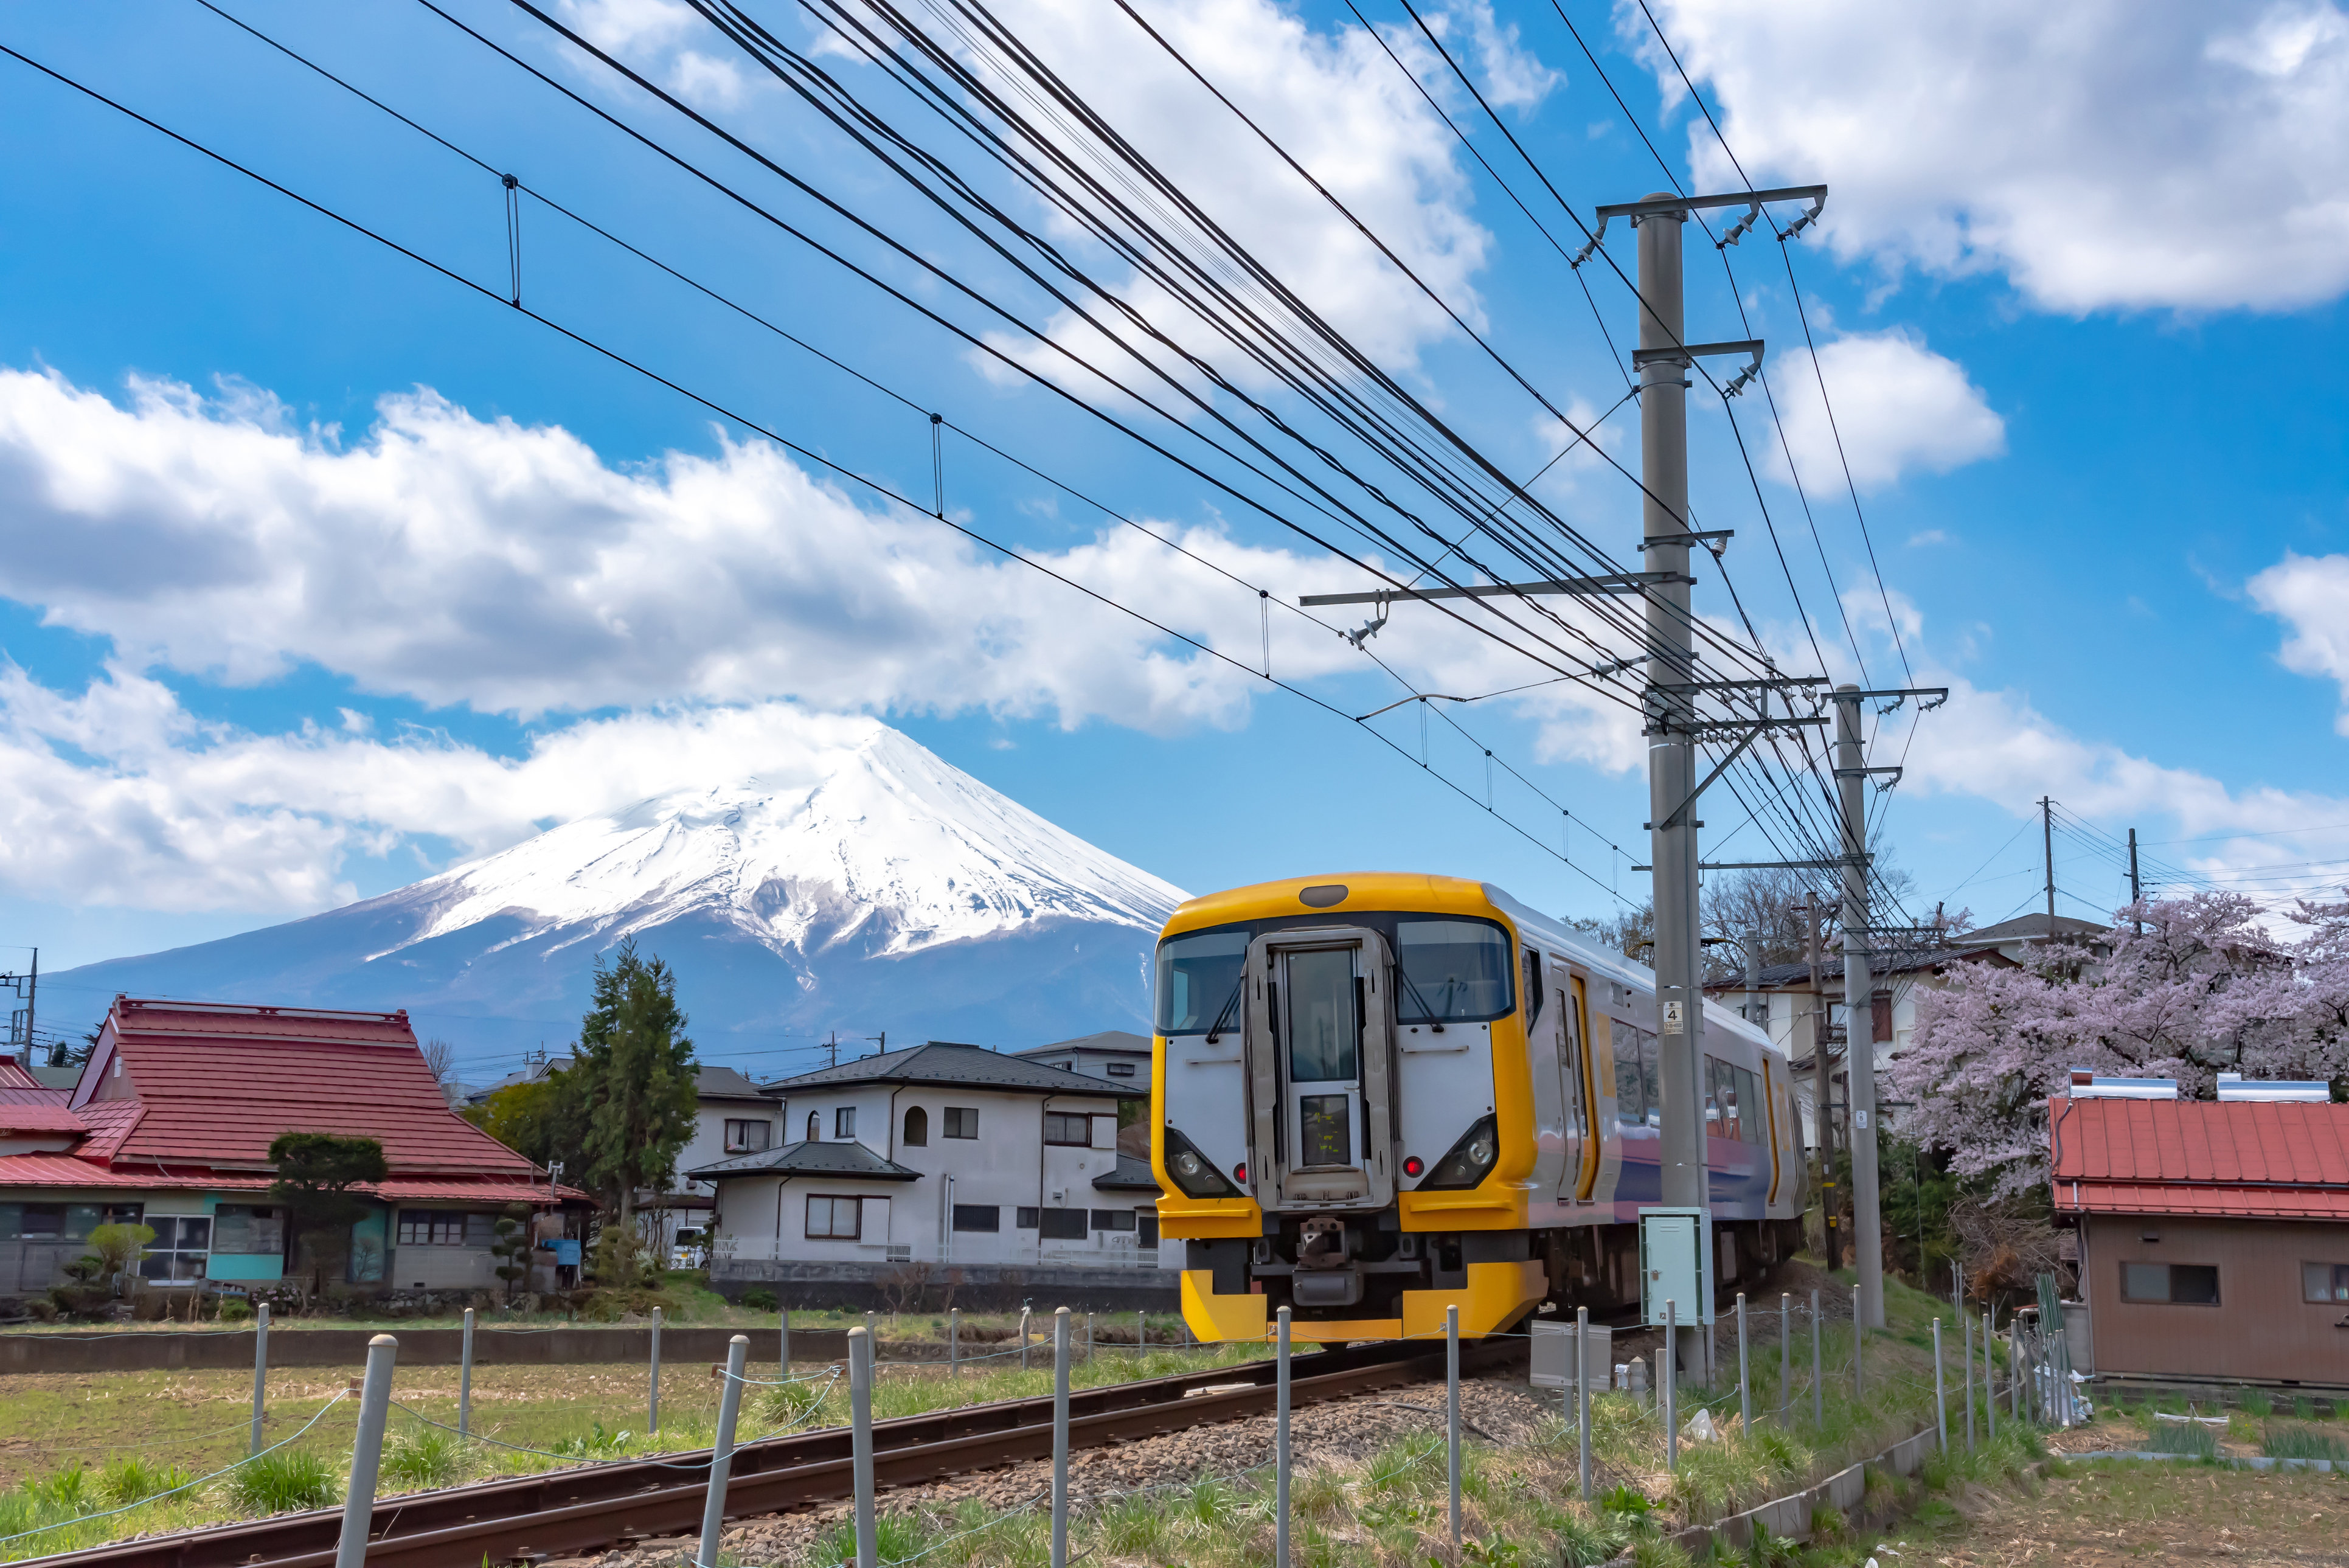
[33,1341,1522,1568]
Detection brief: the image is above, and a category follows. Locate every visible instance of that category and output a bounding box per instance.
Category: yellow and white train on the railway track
[1151,873,1806,1341]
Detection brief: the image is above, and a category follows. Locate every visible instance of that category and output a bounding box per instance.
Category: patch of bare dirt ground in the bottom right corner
[1879,1460,2349,1568]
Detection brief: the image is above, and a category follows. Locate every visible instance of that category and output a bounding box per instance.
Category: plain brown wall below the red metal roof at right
[2081,1213,2349,1387]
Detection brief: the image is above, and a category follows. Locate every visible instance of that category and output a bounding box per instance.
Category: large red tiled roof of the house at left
[77,997,533,1178]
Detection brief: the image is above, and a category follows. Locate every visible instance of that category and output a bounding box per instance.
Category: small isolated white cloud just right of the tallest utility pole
[1766,328,2006,493]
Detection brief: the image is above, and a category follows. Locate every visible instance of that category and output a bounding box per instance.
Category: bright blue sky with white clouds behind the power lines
[0,0,2349,985]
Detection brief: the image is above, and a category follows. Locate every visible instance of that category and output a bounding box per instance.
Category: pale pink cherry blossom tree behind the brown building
[1884,892,2349,1195]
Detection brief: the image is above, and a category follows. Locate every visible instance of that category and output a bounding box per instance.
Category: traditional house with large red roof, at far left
[0,995,583,1293]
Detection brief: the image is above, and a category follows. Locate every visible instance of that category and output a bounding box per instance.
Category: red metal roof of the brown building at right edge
[2049,1098,2349,1218]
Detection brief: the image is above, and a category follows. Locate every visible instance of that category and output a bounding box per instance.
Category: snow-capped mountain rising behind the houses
[54,723,1186,1077]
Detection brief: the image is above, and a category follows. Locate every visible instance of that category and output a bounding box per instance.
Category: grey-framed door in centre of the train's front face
[1250,929,1393,1209]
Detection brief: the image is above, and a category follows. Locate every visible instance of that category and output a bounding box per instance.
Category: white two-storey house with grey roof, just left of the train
[686,1042,1174,1308]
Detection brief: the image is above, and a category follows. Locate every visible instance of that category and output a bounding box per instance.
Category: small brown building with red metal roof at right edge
[2049,1075,2349,1390]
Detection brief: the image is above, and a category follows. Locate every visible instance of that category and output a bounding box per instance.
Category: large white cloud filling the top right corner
[1619,0,2349,312]
